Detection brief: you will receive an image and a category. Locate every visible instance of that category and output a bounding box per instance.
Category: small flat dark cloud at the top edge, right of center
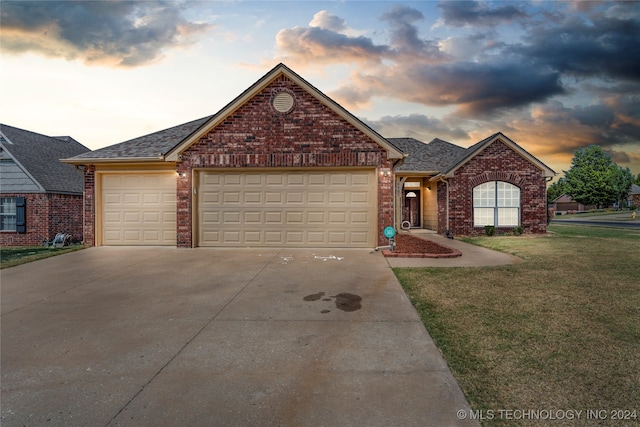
[438,1,528,27]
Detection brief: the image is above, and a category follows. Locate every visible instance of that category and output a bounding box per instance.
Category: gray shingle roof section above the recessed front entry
[387,138,466,172]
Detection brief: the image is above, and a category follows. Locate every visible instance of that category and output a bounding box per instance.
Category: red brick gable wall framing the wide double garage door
[177,76,393,247]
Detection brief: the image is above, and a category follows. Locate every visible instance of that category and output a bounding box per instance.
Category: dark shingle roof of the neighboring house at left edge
[0,124,89,194]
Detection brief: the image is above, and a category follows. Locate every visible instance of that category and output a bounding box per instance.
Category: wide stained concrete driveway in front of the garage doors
[1,247,477,426]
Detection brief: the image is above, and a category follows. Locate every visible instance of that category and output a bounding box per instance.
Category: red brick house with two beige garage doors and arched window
[64,64,553,247]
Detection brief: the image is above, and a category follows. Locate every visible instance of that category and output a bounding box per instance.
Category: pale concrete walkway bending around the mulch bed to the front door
[387,230,522,267]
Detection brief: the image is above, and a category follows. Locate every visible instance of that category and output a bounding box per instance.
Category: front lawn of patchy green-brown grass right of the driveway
[394,225,640,426]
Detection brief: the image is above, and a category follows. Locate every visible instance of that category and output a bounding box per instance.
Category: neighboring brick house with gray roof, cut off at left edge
[0,124,89,246]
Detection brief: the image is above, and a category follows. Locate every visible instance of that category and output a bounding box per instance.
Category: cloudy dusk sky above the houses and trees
[0,0,640,176]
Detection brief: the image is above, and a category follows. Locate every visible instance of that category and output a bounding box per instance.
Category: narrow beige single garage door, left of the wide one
[102,172,176,246]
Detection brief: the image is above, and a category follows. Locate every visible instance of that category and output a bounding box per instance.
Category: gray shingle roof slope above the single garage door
[74,116,213,159]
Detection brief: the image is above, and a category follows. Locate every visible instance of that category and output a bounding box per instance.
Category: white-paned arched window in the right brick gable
[473,181,520,227]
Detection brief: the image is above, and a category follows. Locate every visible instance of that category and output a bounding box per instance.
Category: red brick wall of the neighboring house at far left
[0,193,83,246]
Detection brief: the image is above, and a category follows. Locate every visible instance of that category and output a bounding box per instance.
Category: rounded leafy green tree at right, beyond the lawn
[564,145,633,207]
